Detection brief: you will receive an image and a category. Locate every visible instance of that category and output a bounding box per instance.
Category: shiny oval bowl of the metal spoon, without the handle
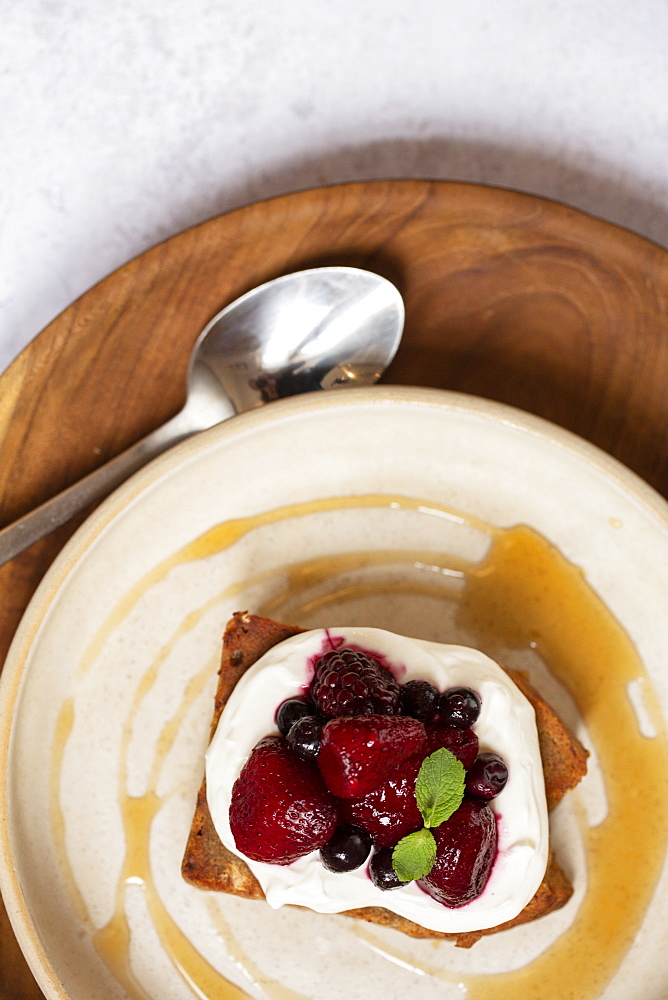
[190,267,404,413]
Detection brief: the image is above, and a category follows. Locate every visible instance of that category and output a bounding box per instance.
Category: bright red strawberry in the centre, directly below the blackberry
[318,715,425,799]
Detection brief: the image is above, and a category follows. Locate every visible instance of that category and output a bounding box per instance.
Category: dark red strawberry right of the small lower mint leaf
[417,798,497,907]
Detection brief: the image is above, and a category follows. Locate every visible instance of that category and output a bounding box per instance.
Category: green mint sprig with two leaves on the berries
[392,747,466,882]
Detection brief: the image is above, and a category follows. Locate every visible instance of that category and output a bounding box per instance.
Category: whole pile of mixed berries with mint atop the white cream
[230,647,508,907]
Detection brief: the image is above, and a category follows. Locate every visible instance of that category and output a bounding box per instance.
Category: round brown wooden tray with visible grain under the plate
[0,181,668,1000]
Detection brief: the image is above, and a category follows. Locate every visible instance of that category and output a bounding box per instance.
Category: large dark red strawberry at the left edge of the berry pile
[230,736,338,865]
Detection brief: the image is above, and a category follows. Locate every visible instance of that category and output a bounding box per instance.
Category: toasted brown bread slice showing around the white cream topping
[181,613,588,948]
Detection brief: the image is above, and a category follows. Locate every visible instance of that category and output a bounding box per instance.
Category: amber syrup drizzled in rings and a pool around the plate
[52,496,668,1000]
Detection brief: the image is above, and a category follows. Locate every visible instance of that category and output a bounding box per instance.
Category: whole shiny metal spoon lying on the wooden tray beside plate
[0,267,404,566]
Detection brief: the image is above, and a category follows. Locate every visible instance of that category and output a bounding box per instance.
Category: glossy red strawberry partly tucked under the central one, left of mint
[339,753,424,847]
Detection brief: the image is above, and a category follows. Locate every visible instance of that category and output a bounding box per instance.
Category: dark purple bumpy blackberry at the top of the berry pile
[309,647,400,719]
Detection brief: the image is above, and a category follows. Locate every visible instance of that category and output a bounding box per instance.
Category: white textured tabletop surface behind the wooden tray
[0,0,668,370]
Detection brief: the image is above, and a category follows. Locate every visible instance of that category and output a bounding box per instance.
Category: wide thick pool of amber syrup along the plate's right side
[461,527,668,1000]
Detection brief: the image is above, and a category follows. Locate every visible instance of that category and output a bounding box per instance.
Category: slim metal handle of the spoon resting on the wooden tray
[0,407,224,566]
